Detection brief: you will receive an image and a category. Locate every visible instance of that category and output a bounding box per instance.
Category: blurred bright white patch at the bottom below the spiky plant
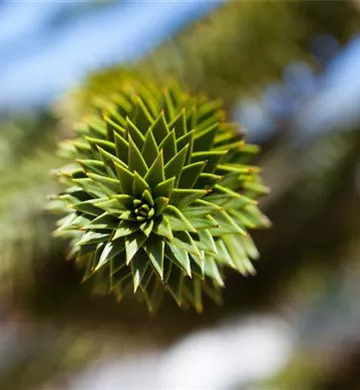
[59,316,294,390]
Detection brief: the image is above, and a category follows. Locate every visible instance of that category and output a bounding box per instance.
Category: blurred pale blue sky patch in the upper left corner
[0,0,223,111]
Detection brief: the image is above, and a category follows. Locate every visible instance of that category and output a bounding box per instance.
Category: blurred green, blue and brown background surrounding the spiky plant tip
[0,0,360,390]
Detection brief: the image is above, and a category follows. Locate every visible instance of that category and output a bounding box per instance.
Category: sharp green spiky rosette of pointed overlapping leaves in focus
[54,82,268,311]
